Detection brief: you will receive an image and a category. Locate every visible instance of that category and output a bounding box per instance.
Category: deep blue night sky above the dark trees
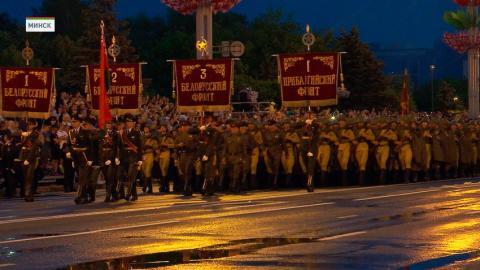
[0,0,455,48]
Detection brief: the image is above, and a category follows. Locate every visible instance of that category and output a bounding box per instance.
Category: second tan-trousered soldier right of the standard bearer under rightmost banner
[337,119,355,186]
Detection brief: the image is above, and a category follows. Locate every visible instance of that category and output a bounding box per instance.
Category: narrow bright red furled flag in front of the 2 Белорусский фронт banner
[98,21,112,128]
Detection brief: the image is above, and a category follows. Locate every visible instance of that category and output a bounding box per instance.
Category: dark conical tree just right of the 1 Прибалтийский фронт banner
[337,28,396,109]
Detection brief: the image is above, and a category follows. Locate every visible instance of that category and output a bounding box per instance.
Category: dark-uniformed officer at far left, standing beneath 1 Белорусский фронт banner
[18,119,42,202]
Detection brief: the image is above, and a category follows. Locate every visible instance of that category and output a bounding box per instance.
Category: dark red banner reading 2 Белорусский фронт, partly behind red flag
[85,64,143,113]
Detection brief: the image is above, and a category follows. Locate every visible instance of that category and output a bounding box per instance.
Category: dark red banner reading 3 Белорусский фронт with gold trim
[173,59,233,112]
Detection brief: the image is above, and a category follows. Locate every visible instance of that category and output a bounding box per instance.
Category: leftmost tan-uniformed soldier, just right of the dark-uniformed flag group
[141,126,158,194]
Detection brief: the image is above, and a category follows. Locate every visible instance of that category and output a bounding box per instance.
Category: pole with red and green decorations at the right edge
[444,0,480,118]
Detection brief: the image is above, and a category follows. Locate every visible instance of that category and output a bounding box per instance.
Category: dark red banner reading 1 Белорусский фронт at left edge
[0,67,55,118]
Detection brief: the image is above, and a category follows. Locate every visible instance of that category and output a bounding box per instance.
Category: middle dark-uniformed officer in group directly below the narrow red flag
[99,119,120,202]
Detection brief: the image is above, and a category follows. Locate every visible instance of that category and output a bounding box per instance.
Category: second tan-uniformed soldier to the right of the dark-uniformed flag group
[156,125,175,193]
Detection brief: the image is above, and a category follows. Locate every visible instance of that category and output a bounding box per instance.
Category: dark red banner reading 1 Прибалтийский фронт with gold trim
[278,53,340,107]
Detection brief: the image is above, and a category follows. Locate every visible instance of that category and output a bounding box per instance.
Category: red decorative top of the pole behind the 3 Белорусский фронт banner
[162,0,244,15]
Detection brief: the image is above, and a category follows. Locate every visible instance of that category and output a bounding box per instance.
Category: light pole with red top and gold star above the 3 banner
[162,0,241,59]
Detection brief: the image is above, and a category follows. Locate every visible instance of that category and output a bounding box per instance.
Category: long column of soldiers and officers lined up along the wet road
[0,114,480,204]
